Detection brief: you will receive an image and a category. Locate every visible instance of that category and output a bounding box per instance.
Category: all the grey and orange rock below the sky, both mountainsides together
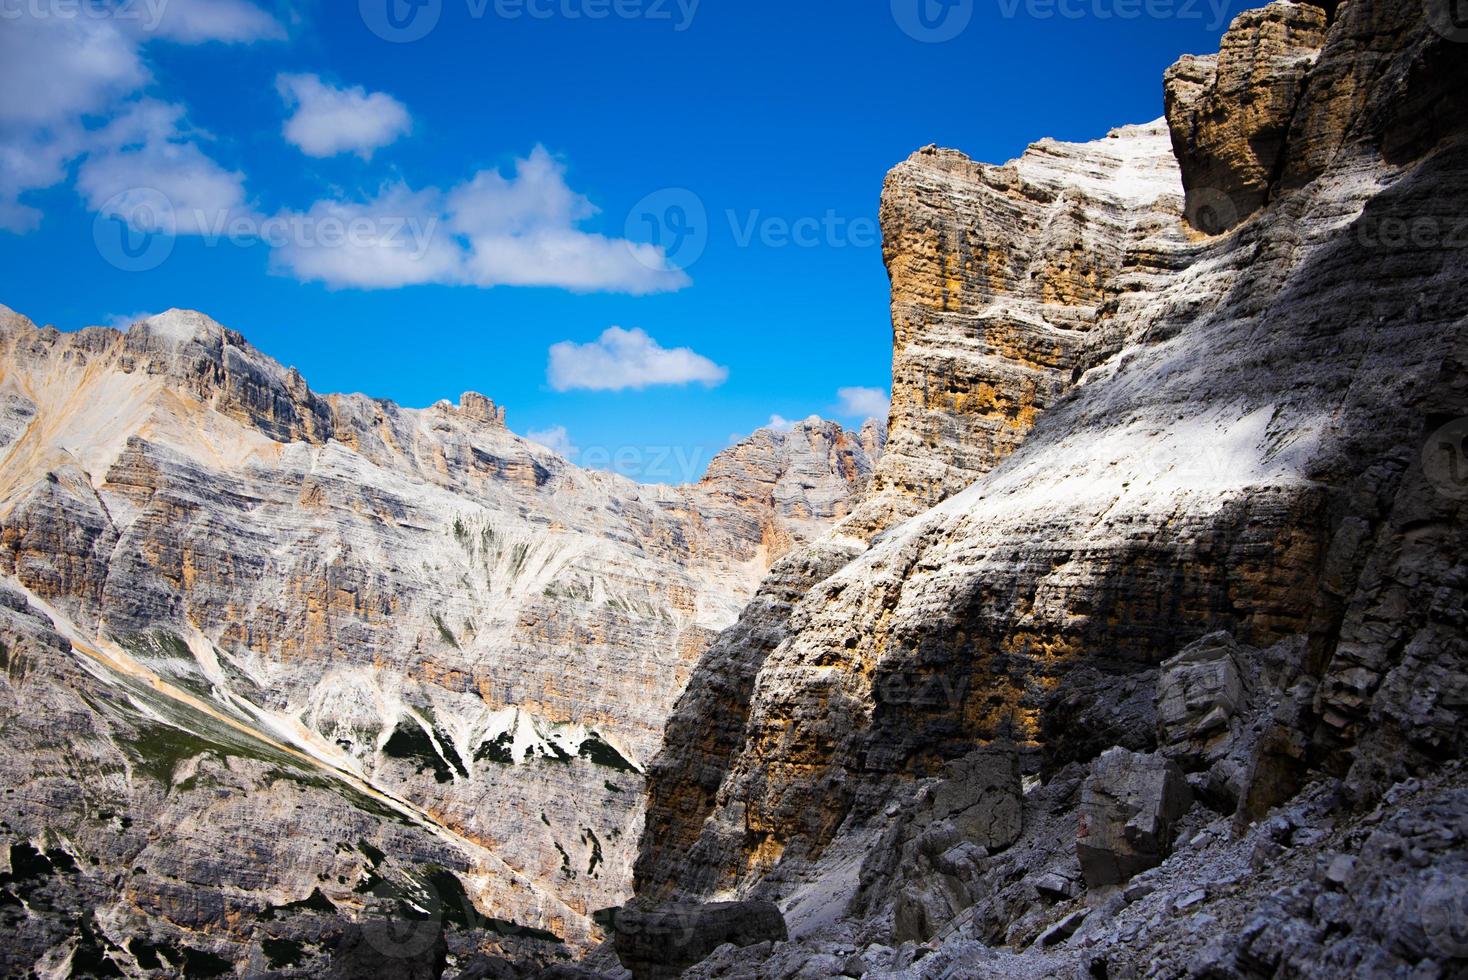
[0,0,1468,980]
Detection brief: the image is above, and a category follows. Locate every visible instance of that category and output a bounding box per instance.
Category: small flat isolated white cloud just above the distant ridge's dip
[546,327,730,392]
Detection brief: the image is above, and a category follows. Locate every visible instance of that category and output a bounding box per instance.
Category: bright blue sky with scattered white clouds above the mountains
[0,0,1242,480]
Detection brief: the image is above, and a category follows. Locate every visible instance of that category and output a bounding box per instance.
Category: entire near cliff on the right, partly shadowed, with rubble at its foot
[637,0,1468,977]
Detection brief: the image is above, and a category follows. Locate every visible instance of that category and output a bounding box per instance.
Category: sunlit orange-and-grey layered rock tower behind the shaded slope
[849,123,1179,531]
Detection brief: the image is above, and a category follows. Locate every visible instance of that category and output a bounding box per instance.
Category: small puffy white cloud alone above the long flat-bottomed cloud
[276,75,413,160]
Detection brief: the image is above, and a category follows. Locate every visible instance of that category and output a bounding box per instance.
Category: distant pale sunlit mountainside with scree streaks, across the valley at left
[0,310,875,973]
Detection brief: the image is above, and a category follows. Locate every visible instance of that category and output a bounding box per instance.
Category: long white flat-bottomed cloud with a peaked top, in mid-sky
[273,147,690,295]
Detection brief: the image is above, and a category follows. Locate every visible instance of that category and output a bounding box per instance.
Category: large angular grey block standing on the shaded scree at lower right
[1076,748,1192,888]
